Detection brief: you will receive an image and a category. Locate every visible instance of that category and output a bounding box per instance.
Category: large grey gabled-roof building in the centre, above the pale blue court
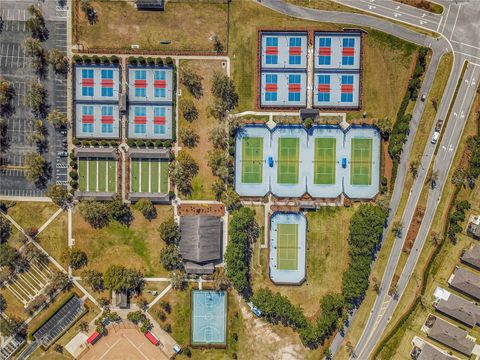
[179,215,223,274]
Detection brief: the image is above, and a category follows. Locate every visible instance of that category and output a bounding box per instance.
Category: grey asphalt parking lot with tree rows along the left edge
[0,0,67,197]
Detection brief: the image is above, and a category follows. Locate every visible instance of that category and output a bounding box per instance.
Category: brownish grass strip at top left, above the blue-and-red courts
[74,0,227,51]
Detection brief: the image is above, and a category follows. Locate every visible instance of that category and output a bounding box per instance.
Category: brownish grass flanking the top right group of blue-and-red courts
[230,1,417,119]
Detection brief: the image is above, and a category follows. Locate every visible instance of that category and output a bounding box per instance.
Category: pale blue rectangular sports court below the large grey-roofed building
[191,290,227,345]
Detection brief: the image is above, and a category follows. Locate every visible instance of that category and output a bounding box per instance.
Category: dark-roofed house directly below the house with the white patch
[424,315,475,356]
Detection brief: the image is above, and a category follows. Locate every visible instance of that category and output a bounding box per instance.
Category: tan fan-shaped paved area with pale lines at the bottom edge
[79,323,168,360]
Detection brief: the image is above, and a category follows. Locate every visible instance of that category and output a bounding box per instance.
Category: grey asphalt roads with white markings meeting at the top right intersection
[262,0,480,359]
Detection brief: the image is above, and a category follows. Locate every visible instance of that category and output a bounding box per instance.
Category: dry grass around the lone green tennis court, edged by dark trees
[251,206,356,317]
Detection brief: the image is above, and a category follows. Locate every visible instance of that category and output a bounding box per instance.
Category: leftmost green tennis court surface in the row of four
[242,138,263,184]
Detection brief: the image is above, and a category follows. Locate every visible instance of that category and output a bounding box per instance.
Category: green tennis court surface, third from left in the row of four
[313,138,337,185]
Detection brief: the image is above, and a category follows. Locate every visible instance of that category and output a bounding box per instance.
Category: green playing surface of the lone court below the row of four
[277,224,298,270]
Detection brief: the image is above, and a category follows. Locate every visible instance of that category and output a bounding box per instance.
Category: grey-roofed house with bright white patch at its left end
[433,287,480,327]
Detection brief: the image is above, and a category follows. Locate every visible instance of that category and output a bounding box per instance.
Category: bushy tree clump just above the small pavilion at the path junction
[103,265,144,293]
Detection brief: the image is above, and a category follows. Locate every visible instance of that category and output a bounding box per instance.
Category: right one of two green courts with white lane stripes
[130,158,168,193]
